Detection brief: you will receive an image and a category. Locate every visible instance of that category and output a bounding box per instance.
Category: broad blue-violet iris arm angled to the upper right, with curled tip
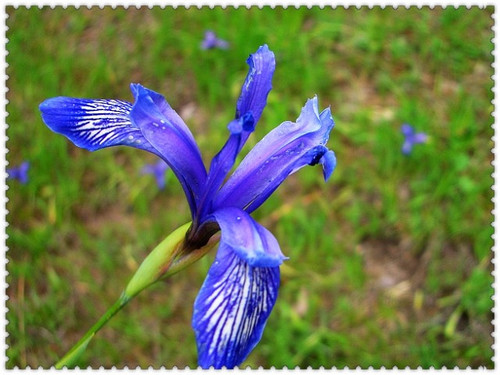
[213,97,336,213]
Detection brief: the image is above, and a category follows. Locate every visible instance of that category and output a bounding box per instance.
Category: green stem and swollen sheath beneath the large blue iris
[55,223,220,369]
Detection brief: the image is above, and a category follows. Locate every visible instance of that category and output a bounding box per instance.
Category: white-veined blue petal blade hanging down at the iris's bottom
[192,239,279,369]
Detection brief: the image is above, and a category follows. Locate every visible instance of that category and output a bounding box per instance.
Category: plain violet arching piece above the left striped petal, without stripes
[130,84,207,217]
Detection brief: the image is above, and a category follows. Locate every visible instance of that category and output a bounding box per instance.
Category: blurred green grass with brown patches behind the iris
[7,7,493,368]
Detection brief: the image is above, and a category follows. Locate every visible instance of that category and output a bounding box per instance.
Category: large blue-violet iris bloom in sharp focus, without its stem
[40,45,336,368]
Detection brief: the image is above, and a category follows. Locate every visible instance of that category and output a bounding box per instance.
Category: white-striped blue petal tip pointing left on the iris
[40,96,159,155]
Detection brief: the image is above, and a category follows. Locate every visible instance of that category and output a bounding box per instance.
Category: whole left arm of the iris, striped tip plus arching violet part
[40,84,206,215]
